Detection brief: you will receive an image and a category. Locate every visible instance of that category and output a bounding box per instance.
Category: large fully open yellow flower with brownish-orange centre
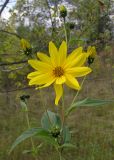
[27,41,91,105]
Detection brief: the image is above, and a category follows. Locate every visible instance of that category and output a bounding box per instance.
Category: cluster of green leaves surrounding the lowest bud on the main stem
[9,111,74,153]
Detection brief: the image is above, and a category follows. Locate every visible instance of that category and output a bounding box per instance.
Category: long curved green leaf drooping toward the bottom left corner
[9,128,43,153]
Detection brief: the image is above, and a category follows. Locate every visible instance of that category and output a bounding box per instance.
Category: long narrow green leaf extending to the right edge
[66,98,114,116]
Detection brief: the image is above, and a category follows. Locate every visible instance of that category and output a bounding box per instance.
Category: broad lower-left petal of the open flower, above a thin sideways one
[29,73,52,85]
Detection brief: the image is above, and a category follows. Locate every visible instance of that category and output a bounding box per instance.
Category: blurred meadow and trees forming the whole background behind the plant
[0,0,114,160]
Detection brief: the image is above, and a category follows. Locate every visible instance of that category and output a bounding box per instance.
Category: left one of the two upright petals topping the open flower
[49,41,59,66]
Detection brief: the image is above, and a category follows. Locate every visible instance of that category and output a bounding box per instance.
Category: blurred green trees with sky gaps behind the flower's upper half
[0,0,112,91]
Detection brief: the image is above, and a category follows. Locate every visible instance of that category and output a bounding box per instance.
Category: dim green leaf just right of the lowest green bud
[63,126,71,143]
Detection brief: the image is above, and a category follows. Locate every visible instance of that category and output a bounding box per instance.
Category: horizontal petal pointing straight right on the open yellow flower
[66,67,92,77]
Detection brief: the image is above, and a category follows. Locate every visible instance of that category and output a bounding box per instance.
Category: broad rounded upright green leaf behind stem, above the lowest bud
[41,111,61,131]
